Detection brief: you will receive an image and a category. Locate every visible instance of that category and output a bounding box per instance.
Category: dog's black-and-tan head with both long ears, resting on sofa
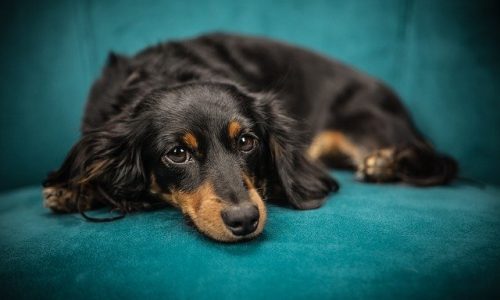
[47,83,337,241]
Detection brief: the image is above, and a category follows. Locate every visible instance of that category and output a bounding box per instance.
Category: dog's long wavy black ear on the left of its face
[43,117,148,209]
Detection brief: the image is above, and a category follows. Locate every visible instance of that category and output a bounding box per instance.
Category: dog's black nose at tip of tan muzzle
[221,203,259,236]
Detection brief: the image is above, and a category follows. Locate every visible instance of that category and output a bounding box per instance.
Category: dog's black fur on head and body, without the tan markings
[44,34,457,213]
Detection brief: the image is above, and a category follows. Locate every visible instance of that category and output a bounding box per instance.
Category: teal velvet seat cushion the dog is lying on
[0,172,500,299]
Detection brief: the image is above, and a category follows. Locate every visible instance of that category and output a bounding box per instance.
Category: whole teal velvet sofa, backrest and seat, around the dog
[0,0,500,299]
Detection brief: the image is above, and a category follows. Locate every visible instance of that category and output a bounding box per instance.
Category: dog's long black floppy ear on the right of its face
[254,95,339,209]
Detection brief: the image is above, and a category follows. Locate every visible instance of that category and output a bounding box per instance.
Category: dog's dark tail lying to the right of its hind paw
[396,147,458,186]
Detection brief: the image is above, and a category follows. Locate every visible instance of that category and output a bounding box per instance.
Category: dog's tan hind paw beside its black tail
[356,149,397,182]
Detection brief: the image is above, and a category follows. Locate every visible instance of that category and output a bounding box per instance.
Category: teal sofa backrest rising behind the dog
[0,0,500,189]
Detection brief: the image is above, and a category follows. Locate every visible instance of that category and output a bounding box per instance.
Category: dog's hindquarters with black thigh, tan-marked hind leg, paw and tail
[308,83,457,185]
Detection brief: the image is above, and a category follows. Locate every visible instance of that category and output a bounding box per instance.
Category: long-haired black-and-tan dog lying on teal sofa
[43,33,458,242]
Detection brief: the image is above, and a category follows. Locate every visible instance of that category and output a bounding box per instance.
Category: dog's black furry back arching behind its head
[83,33,372,132]
